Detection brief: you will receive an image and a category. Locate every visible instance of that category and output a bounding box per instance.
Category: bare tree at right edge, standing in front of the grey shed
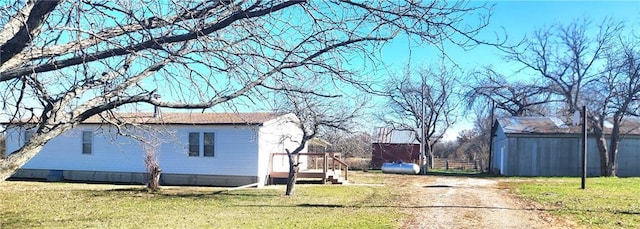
[584,38,640,176]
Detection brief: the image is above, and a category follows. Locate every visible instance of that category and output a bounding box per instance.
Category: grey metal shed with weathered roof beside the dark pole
[491,117,640,177]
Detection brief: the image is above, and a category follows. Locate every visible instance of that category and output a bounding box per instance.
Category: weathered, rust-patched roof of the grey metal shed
[498,117,640,135]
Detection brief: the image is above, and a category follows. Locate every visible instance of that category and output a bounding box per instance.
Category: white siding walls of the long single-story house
[7,120,298,181]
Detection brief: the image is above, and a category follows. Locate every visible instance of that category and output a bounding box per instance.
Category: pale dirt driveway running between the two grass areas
[394,175,575,228]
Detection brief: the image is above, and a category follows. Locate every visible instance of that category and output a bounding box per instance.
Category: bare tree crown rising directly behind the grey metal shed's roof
[506,19,622,117]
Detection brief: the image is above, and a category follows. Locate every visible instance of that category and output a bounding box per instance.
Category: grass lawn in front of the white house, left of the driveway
[0,174,402,228]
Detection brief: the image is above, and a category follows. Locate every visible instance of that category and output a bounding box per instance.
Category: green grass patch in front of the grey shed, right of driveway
[506,178,640,228]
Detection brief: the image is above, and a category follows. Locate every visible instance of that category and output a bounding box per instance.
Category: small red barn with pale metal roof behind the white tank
[371,128,420,168]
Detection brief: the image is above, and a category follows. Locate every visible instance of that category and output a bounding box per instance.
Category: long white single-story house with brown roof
[5,113,302,186]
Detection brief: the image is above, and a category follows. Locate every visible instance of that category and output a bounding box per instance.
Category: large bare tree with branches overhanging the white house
[0,0,490,180]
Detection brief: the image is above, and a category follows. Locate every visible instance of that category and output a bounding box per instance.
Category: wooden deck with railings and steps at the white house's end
[269,153,349,184]
